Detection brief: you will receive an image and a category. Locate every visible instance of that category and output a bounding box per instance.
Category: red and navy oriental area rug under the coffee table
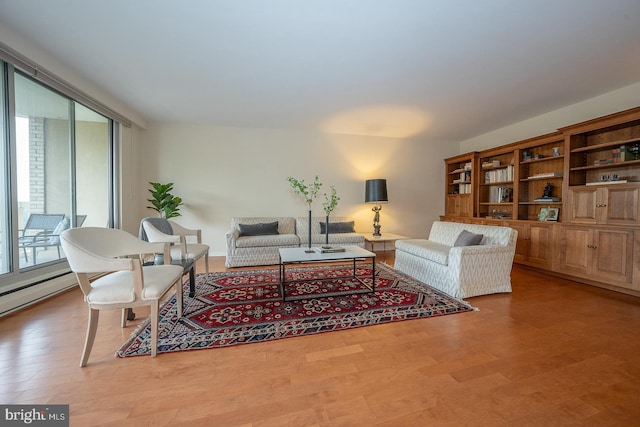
[116,264,473,357]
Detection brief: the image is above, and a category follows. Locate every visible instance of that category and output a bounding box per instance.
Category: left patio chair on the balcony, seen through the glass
[18,214,65,264]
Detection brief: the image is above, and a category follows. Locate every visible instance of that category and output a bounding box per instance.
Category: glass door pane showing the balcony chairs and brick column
[14,74,72,268]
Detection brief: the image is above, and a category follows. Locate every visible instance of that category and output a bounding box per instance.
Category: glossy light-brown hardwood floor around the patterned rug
[0,258,640,426]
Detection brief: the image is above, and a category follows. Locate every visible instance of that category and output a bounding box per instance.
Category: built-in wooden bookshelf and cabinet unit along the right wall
[442,107,640,296]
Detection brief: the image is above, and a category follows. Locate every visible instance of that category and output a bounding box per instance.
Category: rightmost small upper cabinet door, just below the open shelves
[598,186,640,225]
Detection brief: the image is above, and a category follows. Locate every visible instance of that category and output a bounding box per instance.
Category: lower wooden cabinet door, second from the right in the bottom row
[558,227,594,277]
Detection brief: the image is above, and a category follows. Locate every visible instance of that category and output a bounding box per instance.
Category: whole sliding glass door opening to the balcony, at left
[0,62,118,297]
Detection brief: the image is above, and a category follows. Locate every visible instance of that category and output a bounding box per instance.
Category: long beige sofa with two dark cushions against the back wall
[225,217,364,267]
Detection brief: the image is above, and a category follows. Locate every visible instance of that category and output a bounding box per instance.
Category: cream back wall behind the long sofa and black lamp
[138,123,458,255]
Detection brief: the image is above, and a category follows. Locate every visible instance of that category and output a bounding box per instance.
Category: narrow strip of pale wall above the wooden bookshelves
[460,82,640,153]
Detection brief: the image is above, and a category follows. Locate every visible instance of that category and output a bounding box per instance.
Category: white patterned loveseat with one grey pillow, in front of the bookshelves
[394,221,518,298]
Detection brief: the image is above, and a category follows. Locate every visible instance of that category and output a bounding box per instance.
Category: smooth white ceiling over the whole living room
[0,0,640,141]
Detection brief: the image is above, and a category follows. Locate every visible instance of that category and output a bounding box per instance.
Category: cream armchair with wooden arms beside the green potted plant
[138,217,209,273]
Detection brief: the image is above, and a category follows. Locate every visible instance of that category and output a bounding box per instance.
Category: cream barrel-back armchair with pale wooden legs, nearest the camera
[60,227,183,367]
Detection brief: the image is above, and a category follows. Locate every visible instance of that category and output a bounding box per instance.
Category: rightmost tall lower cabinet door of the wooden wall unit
[592,229,634,288]
